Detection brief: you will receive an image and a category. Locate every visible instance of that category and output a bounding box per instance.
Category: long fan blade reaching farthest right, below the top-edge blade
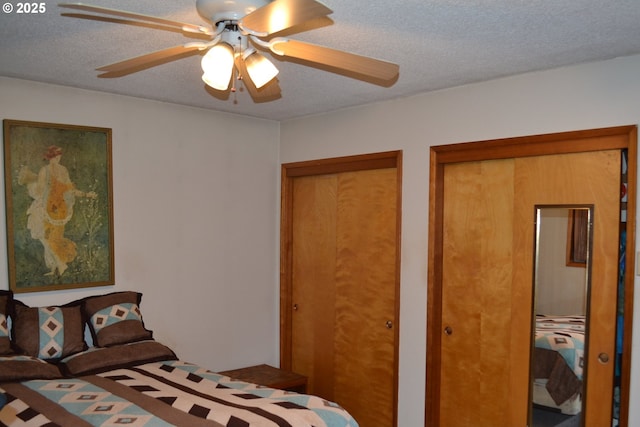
[271,39,400,82]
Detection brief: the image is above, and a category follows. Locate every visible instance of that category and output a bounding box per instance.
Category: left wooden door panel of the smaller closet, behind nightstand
[291,175,338,400]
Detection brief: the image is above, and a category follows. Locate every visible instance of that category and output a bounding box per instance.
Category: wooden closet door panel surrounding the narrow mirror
[514,150,621,427]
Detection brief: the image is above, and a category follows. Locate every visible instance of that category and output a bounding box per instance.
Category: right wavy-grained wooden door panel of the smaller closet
[335,168,398,427]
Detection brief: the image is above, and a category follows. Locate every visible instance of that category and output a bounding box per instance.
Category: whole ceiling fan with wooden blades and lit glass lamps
[59,0,399,102]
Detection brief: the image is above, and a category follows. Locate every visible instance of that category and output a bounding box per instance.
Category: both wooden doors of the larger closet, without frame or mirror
[439,150,621,427]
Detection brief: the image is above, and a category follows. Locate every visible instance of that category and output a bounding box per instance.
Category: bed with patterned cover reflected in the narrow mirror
[533,315,585,415]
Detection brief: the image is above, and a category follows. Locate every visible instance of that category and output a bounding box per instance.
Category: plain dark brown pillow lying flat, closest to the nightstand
[59,340,177,376]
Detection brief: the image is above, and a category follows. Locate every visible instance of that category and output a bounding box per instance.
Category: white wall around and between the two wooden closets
[280,56,640,427]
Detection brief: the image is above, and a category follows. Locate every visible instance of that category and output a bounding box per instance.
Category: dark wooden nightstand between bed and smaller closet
[218,365,307,394]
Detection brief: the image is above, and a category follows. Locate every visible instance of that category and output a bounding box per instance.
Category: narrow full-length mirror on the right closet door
[531,206,593,427]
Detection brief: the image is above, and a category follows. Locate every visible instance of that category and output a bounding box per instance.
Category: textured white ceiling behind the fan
[0,0,640,120]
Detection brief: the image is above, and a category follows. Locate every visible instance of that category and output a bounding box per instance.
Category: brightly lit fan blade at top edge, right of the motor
[238,0,333,37]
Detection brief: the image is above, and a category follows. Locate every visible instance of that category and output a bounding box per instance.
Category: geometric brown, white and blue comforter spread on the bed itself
[0,360,358,427]
